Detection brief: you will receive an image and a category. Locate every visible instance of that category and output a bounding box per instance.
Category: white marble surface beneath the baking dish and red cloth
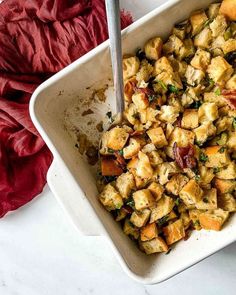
[0,0,236,295]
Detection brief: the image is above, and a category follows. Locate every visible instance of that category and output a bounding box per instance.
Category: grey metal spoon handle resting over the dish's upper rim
[106,0,124,114]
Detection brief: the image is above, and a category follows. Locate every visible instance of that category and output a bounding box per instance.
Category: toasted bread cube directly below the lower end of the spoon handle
[107,127,129,151]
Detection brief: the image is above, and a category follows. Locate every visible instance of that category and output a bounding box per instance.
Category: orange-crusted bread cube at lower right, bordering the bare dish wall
[199,209,229,231]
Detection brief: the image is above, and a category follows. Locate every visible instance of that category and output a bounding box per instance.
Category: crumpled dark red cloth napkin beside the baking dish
[0,0,132,217]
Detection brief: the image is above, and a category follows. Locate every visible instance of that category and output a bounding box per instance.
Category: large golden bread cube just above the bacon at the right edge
[207,56,233,86]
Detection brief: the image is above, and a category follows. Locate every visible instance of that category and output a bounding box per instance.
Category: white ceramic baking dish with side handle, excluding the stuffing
[30,0,236,284]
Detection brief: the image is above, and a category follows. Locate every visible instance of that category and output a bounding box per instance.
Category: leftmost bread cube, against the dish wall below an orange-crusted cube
[98,183,123,211]
